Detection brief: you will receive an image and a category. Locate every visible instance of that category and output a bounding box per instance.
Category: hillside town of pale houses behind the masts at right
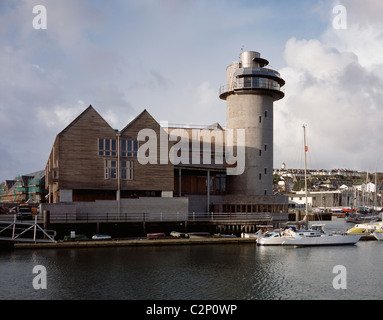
[273,163,383,211]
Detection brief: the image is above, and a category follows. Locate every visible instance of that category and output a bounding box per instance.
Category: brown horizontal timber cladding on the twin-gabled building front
[46,106,174,200]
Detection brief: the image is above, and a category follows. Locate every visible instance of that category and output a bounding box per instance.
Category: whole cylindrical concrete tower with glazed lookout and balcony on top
[219,51,285,196]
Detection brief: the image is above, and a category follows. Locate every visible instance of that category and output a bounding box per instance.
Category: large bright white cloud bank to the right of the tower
[275,1,383,170]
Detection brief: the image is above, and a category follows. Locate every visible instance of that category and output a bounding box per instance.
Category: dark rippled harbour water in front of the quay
[0,218,383,300]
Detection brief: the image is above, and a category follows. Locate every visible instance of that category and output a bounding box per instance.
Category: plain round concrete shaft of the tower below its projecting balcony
[226,93,273,195]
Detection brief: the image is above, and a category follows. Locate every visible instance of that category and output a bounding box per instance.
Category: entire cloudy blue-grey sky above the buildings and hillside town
[0,0,383,181]
